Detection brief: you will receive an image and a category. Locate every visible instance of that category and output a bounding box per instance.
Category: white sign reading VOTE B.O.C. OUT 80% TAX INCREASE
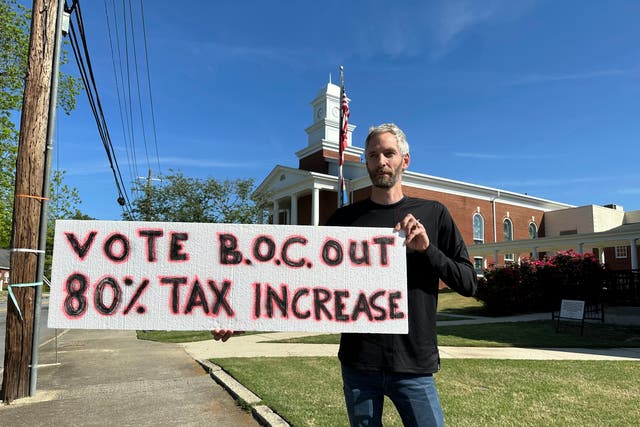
[49,221,408,333]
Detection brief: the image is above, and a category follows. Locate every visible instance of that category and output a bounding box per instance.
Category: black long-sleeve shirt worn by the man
[327,196,476,374]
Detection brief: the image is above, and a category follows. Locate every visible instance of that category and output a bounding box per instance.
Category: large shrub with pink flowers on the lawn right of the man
[476,250,605,315]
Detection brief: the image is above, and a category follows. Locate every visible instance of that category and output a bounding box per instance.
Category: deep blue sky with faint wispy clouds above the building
[54,0,640,219]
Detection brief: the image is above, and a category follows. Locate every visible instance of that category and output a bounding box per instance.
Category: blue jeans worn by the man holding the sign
[342,365,444,427]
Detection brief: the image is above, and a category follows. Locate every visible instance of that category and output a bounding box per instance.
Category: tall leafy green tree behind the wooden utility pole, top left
[0,0,81,247]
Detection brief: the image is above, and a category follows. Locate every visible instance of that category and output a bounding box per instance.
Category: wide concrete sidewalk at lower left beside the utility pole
[0,329,259,427]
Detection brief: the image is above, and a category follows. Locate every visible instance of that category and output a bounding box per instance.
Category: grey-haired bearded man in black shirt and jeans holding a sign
[328,124,476,426]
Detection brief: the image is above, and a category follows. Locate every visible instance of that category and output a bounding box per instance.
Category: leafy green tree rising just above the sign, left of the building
[124,171,266,224]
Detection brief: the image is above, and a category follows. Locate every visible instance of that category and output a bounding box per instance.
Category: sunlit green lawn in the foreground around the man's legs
[213,357,640,427]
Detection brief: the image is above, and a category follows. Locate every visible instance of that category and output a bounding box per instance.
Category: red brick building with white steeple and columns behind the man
[256,83,640,271]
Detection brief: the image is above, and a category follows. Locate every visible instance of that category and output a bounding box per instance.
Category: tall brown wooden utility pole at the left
[0,0,61,403]
